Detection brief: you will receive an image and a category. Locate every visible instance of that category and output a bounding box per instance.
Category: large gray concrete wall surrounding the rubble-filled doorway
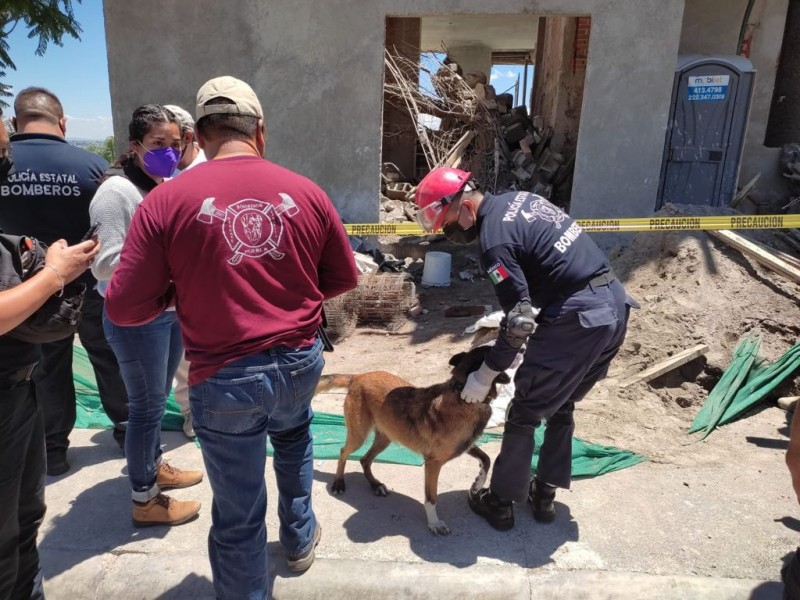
[104,0,684,222]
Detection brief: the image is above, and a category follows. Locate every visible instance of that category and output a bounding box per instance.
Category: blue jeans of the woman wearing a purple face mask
[103,311,183,502]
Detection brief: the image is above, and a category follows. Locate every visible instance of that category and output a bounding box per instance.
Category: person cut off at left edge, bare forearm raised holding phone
[0,112,99,599]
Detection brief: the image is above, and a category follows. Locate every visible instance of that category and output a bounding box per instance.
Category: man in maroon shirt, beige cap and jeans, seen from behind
[106,77,358,598]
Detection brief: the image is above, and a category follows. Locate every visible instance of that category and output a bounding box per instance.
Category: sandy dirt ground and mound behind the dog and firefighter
[316,207,800,490]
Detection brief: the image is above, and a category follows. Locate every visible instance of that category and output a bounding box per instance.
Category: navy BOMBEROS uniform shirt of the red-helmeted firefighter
[478,192,611,370]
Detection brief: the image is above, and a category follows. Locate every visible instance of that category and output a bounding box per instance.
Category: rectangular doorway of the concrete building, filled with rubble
[381,14,591,221]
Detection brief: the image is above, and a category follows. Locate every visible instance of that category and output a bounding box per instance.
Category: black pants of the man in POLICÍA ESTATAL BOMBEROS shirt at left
[34,290,128,455]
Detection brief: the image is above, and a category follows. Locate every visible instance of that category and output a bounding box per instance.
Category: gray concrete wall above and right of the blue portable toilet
[680,0,788,207]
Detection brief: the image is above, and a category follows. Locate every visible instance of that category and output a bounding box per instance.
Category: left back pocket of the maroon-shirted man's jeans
[201,373,266,433]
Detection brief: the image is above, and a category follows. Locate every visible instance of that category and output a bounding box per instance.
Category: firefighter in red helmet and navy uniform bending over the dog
[416,168,638,530]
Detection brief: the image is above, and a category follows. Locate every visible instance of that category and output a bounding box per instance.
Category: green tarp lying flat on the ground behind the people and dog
[73,346,646,478]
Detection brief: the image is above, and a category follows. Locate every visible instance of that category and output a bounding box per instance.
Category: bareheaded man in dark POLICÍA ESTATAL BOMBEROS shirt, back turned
[0,88,128,475]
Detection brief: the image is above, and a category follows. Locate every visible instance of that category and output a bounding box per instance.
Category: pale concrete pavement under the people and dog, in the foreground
[34,409,800,600]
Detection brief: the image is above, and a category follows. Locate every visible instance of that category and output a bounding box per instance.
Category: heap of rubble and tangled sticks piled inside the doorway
[381,49,574,227]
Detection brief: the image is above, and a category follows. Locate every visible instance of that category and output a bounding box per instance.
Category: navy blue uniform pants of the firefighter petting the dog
[491,280,635,502]
